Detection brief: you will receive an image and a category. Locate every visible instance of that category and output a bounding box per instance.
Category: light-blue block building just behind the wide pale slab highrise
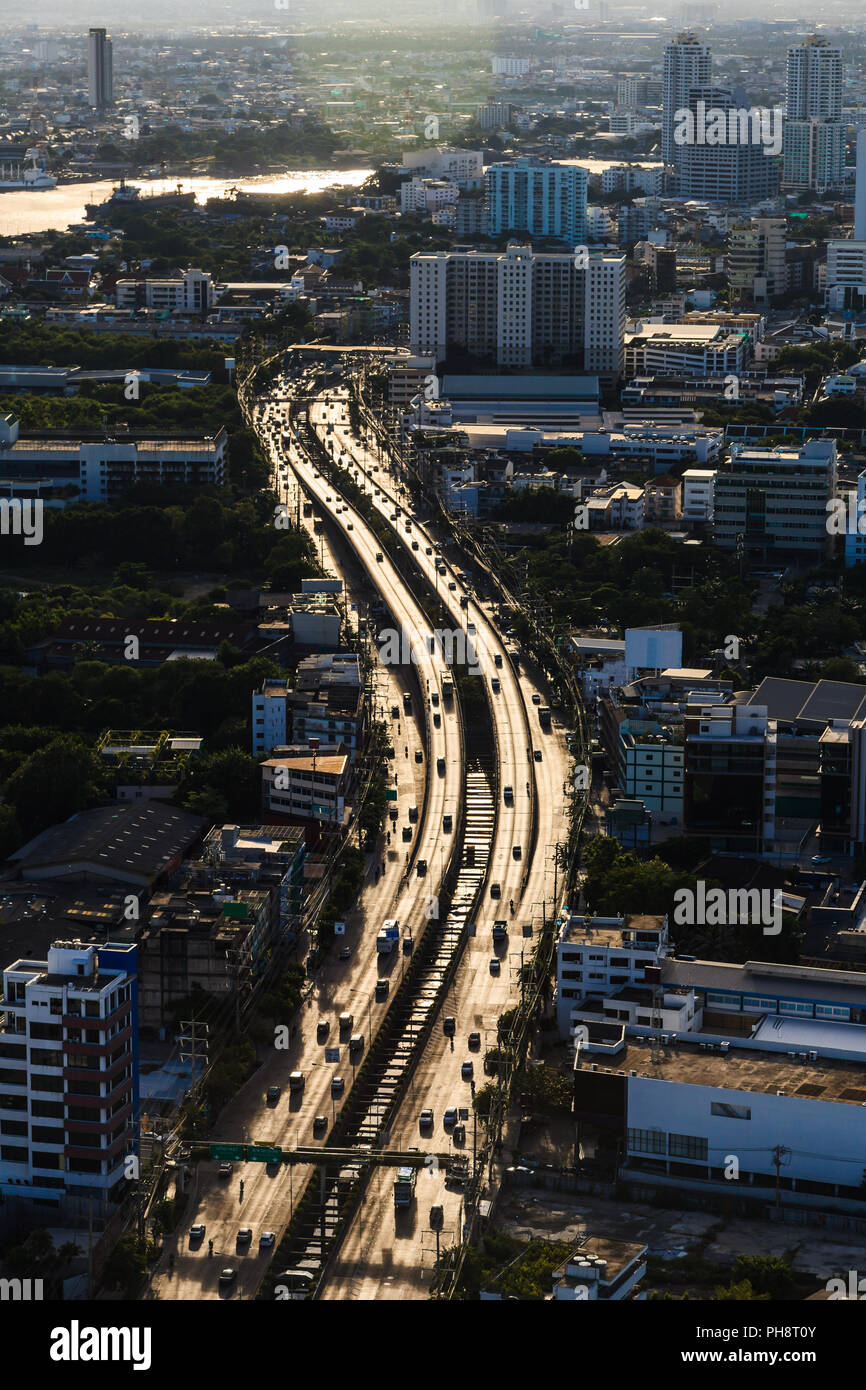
[484,160,587,246]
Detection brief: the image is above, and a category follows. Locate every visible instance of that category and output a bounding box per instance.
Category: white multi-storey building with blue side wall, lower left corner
[0,941,139,1225]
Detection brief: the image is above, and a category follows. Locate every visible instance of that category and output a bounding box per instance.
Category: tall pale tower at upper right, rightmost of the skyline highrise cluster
[781,35,845,193]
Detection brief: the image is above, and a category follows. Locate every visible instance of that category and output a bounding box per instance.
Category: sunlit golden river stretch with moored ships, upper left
[0,170,373,236]
